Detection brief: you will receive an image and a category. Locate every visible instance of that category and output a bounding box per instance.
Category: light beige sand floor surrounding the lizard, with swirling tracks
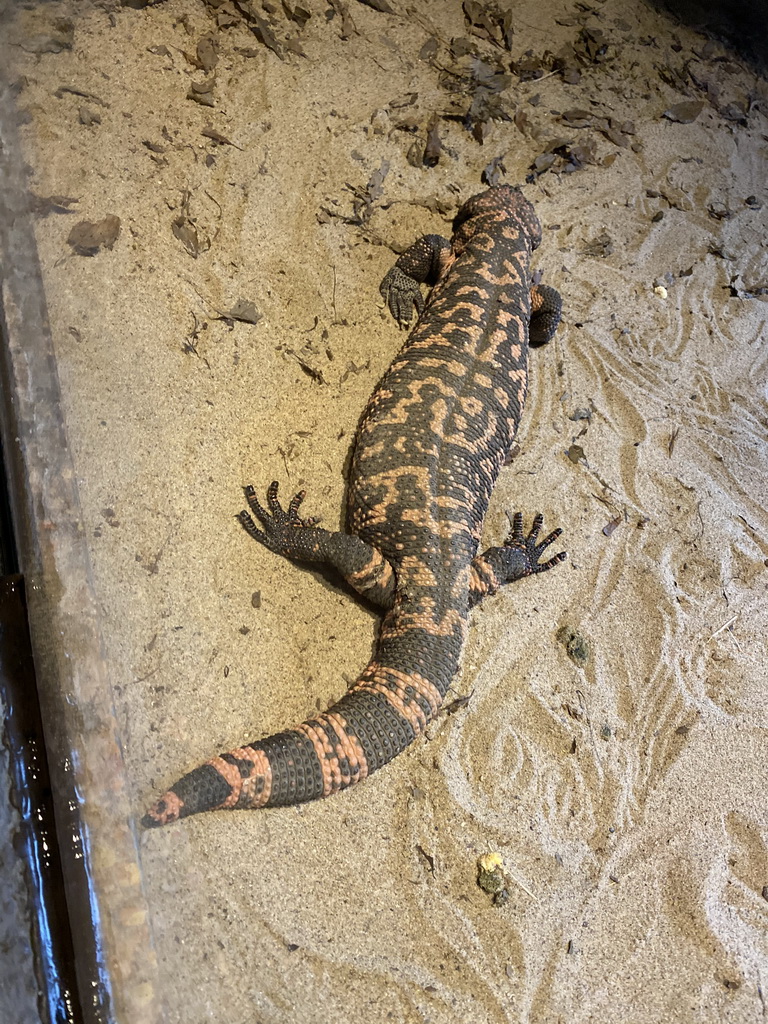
[1,0,768,1024]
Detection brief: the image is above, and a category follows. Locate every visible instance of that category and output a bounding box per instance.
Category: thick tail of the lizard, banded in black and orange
[141,660,450,828]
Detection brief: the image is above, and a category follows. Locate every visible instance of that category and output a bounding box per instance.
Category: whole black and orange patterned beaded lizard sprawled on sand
[143,185,565,826]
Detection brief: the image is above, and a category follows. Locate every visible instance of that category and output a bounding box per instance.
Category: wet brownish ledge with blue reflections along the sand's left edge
[0,66,161,1024]
